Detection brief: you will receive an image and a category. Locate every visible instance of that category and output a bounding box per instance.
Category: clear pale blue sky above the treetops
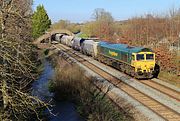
[33,0,180,22]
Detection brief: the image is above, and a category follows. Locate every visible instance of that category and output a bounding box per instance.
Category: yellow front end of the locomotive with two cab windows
[131,52,155,78]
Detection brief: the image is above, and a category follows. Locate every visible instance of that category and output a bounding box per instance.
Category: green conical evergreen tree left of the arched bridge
[32,5,51,38]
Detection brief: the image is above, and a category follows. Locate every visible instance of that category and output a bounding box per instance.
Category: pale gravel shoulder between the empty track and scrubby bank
[52,46,163,121]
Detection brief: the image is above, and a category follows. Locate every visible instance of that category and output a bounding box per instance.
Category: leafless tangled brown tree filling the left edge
[0,0,51,120]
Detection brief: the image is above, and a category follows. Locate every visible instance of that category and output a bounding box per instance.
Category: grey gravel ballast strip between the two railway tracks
[72,49,180,113]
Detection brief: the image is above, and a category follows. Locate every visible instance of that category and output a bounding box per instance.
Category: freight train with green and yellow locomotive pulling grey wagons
[54,34,156,79]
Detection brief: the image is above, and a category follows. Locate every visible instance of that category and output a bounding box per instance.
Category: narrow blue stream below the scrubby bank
[32,60,82,121]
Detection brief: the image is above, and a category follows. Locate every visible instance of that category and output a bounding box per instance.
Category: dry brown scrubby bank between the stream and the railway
[49,55,134,121]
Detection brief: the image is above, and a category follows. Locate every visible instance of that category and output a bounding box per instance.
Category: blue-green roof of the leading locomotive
[99,41,153,53]
